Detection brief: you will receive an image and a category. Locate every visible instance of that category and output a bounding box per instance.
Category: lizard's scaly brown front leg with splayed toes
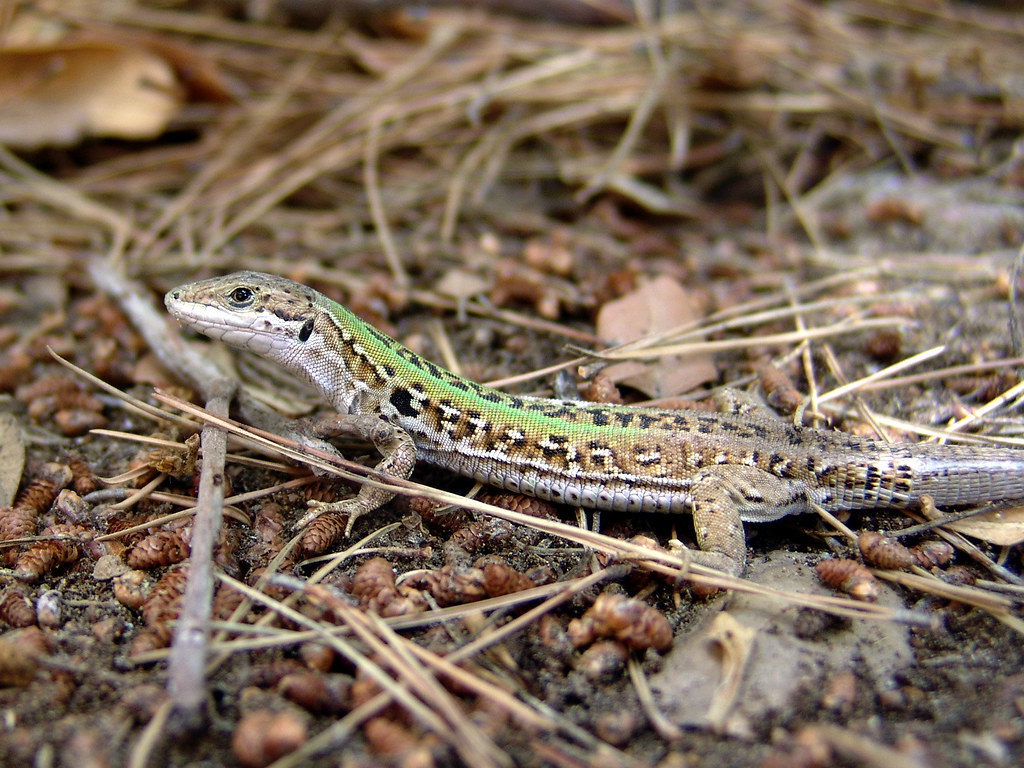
[295,414,416,537]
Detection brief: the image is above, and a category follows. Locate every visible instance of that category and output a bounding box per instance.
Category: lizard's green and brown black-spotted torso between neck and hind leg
[315,288,830,519]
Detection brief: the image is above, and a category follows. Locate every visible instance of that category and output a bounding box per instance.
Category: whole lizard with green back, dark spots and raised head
[165,271,1024,575]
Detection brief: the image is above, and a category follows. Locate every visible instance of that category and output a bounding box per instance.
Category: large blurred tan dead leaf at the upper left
[0,42,181,150]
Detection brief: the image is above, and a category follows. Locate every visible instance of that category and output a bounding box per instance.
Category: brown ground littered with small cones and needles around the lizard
[0,0,1024,768]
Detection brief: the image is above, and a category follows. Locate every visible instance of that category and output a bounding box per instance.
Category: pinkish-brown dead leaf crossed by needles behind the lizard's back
[597,275,717,397]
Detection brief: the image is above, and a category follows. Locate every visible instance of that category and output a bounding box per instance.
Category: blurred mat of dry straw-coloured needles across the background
[0,0,1024,282]
